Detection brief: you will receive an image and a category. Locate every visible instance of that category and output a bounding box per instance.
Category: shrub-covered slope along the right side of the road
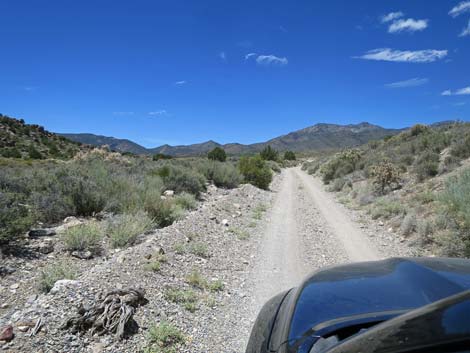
[302,122,470,256]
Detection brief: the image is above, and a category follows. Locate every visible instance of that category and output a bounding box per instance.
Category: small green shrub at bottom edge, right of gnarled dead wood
[144,322,185,353]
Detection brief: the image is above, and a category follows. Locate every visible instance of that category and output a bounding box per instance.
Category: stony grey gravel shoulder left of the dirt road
[0,180,273,352]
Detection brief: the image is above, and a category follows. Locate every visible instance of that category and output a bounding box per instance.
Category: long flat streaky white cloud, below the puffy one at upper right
[355,48,448,63]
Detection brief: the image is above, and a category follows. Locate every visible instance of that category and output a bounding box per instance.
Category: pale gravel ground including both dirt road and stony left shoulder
[0,168,411,353]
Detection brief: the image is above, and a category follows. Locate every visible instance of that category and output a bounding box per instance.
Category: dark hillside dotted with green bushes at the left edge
[0,114,86,159]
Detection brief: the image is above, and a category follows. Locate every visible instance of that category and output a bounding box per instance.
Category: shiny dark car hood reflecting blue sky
[288,258,470,351]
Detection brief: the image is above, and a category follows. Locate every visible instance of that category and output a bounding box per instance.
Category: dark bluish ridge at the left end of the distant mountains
[58,133,147,154]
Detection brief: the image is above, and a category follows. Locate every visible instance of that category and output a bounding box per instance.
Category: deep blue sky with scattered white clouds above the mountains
[0,0,470,147]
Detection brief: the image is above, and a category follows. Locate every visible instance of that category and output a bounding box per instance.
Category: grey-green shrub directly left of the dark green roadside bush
[199,161,243,189]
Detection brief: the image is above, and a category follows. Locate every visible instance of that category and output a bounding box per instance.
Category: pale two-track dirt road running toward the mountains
[253,168,381,312]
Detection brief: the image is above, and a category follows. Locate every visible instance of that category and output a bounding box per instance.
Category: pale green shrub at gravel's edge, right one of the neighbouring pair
[106,211,154,248]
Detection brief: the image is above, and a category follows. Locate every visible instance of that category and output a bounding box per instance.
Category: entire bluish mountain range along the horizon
[59,122,403,157]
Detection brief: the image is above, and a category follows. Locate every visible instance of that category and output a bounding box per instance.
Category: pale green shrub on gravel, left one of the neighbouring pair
[61,221,103,254]
